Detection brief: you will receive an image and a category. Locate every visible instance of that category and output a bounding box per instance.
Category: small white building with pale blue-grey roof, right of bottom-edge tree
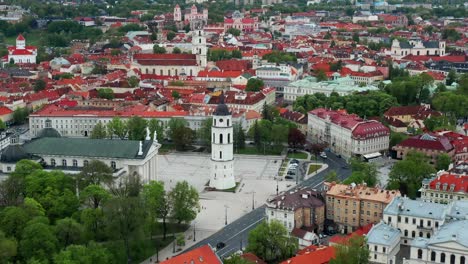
[367,222,401,264]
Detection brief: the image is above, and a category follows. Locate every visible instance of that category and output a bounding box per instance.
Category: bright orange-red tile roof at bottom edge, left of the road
[161,245,222,264]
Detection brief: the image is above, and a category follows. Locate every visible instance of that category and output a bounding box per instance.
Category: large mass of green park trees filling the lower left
[0,160,199,264]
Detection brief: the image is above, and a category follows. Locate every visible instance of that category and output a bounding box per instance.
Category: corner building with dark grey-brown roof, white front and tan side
[265,187,325,233]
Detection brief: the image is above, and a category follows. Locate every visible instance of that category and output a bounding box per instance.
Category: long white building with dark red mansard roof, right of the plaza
[307,108,390,158]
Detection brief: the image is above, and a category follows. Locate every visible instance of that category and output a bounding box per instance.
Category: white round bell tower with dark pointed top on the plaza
[210,94,236,190]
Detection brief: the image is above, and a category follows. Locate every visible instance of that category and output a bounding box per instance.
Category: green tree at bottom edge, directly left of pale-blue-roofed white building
[330,236,370,264]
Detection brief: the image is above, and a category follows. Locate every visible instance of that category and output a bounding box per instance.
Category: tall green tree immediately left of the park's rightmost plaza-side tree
[142,181,172,239]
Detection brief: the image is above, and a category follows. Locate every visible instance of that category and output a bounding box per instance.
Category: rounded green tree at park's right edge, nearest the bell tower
[169,181,200,224]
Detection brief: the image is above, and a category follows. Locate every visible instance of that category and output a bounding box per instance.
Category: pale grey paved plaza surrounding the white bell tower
[157,153,288,233]
